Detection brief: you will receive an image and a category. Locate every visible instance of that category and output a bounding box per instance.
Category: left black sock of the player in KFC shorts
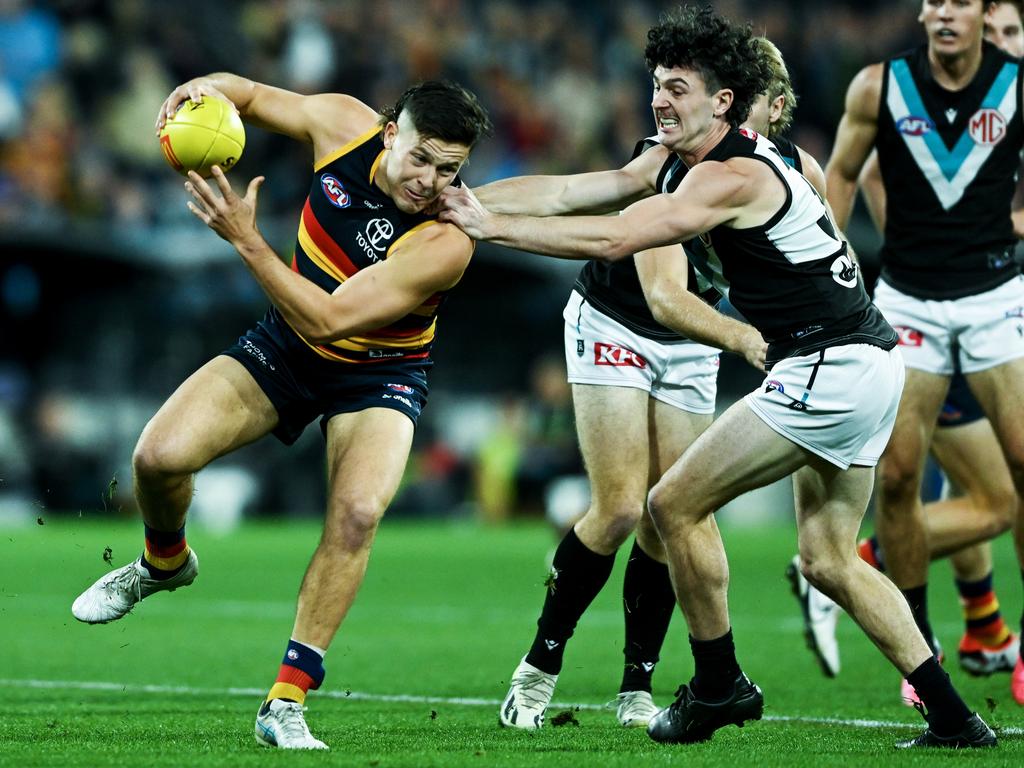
[526,529,615,675]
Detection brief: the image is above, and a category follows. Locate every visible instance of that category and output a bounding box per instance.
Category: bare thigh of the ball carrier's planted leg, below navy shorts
[327,408,415,517]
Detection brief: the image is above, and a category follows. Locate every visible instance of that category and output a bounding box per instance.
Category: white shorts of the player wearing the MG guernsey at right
[874,274,1024,376]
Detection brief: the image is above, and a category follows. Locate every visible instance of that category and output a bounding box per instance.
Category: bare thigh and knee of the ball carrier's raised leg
[137,355,278,473]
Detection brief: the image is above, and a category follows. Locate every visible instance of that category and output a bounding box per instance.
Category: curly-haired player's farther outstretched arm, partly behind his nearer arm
[473,146,669,216]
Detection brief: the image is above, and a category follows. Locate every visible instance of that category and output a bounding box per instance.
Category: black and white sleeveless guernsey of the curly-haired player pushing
[691,130,896,367]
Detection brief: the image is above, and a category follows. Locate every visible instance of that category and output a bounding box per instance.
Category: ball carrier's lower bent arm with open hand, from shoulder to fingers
[188,173,473,344]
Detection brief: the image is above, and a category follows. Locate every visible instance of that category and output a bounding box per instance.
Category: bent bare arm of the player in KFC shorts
[636,245,768,371]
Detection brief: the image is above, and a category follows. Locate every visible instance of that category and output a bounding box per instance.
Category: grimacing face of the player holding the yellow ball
[375,113,470,213]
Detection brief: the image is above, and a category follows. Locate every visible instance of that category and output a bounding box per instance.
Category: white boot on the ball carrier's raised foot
[71,550,199,624]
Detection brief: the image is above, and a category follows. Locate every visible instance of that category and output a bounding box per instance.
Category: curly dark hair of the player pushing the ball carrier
[644,5,772,128]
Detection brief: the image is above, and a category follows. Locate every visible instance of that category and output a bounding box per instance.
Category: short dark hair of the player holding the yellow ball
[381,80,492,147]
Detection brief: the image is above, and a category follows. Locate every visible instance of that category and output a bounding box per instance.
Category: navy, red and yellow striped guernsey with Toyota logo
[292,128,444,364]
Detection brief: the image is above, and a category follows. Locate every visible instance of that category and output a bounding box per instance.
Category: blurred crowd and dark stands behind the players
[0,0,923,522]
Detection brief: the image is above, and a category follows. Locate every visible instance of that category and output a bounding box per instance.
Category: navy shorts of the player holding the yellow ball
[223,307,433,445]
